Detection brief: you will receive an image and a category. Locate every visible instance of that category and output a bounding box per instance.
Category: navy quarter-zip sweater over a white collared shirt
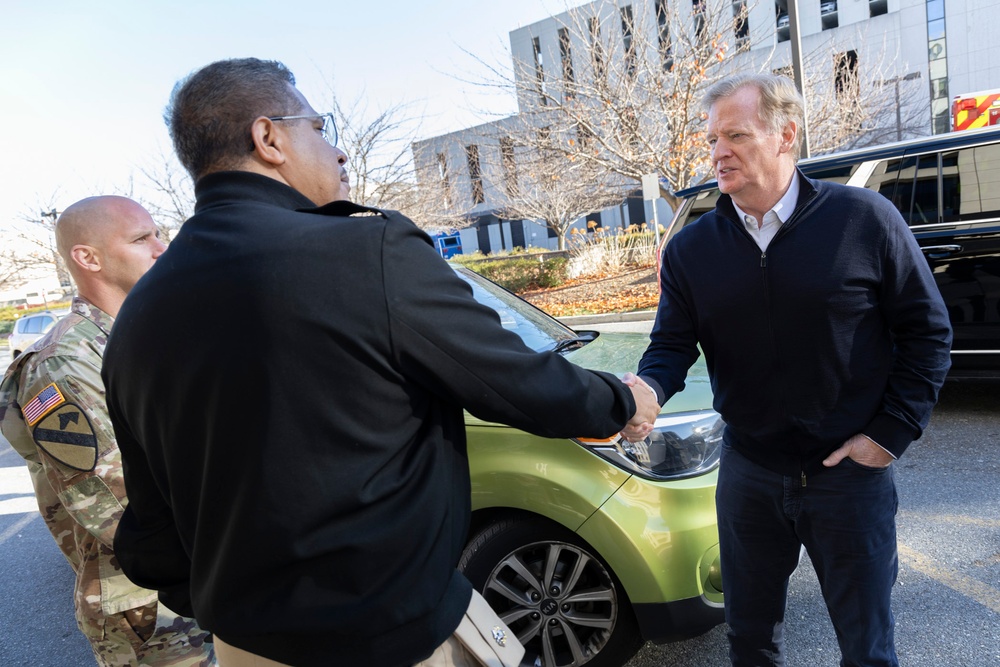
[639,172,951,475]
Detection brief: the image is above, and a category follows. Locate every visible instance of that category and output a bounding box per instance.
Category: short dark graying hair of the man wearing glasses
[163,58,302,180]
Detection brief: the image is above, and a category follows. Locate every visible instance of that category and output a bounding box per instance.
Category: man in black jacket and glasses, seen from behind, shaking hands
[104,59,659,666]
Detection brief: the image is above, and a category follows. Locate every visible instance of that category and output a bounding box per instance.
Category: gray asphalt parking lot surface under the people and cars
[0,342,1000,667]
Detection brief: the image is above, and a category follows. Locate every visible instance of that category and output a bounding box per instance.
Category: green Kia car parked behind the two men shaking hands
[456,268,724,667]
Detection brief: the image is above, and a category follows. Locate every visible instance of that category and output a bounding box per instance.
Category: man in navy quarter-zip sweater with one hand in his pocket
[626,74,951,667]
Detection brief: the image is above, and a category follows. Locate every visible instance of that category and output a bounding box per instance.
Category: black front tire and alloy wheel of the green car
[458,518,643,667]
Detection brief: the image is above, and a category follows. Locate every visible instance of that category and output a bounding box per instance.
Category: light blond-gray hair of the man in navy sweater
[704,73,805,160]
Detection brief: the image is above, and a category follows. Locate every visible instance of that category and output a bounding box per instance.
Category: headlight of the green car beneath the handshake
[576,410,726,480]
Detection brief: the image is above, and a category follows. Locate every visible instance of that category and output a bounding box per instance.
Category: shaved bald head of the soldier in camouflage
[55,195,166,316]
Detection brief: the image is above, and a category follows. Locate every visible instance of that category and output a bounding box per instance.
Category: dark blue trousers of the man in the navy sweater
[716,445,899,667]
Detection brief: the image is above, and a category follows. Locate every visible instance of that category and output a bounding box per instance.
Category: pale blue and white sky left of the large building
[0,0,568,240]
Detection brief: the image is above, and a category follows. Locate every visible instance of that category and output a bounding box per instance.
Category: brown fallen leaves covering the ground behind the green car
[520,266,660,317]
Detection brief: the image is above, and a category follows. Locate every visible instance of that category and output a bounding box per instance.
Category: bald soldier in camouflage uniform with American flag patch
[0,197,215,667]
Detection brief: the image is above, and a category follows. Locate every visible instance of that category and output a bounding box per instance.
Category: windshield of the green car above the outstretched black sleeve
[455,267,579,352]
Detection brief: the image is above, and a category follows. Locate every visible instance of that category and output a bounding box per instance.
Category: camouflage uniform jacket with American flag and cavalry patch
[0,297,156,624]
